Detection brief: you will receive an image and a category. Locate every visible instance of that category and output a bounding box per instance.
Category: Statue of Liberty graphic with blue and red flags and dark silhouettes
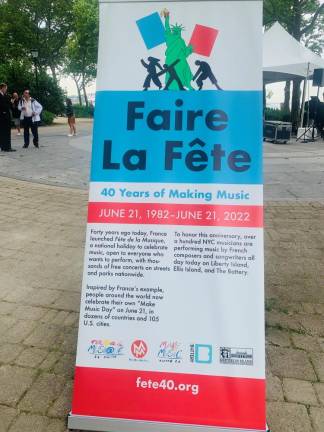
[136,9,222,91]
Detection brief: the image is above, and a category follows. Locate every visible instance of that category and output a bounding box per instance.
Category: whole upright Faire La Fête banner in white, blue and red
[69,0,266,432]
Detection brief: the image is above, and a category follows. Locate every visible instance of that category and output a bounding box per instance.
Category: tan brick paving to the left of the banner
[0,178,87,432]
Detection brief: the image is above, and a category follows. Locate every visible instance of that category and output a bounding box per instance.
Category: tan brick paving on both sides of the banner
[0,178,324,432]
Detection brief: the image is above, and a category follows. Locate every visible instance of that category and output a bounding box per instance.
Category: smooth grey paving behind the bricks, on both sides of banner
[0,118,324,201]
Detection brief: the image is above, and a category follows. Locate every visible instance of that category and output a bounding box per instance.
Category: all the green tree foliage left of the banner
[0,0,99,107]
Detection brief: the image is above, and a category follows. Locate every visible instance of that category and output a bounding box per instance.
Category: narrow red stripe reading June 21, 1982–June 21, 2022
[88,202,263,228]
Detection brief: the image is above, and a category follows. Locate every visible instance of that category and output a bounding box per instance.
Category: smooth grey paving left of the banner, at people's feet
[0,118,92,190]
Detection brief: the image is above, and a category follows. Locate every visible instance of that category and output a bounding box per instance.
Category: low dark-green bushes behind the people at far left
[0,60,64,114]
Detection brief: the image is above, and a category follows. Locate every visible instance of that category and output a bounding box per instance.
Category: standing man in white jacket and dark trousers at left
[18,90,43,148]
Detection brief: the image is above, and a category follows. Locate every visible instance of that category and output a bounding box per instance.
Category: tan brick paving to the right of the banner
[265,202,324,432]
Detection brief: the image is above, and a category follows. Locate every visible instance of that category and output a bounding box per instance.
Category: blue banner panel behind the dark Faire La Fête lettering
[91,91,262,184]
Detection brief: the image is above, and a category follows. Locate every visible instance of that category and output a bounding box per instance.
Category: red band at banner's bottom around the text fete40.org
[72,366,266,430]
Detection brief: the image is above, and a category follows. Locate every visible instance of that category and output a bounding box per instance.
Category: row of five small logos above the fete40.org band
[88,339,253,366]
